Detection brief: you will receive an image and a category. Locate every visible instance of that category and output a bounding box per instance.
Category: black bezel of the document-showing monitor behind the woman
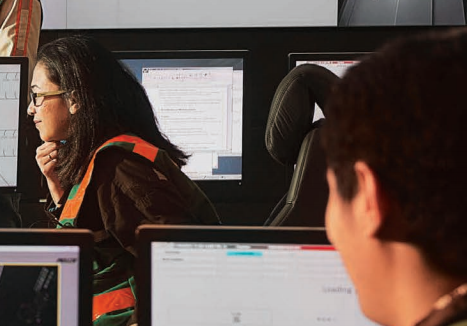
[113,49,251,198]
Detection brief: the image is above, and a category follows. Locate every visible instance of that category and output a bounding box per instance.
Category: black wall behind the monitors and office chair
[23,27,456,225]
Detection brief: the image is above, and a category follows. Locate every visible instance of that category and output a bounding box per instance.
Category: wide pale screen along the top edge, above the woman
[41,0,338,29]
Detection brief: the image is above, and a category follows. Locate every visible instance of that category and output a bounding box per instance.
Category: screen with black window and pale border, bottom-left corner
[0,245,79,325]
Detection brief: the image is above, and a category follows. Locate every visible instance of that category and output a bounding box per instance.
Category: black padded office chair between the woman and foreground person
[264,64,339,227]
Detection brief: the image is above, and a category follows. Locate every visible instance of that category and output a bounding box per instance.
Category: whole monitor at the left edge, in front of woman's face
[0,57,28,192]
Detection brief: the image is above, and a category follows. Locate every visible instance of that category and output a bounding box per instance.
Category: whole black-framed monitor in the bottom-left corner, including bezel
[0,229,94,326]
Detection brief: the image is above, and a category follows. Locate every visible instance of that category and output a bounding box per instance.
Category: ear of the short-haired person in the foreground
[354,161,385,237]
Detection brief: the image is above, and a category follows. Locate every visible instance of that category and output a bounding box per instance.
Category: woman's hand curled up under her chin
[36,142,64,206]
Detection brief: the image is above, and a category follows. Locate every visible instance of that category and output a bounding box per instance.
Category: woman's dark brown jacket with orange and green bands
[49,136,220,326]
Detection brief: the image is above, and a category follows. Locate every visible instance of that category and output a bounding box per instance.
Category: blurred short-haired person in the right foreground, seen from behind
[323,28,467,326]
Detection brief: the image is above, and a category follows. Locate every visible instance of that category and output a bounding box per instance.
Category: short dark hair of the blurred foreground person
[323,29,467,276]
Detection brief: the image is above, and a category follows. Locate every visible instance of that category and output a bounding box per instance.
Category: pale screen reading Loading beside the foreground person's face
[151,242,375,326]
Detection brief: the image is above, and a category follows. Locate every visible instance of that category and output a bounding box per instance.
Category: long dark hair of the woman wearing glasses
[37,36,187,187]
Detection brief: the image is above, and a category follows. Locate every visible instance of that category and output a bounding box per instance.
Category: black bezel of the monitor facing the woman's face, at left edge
[0,57,30,194]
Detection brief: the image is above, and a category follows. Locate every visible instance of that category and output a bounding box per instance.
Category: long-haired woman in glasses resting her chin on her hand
[28,36,220,325]
